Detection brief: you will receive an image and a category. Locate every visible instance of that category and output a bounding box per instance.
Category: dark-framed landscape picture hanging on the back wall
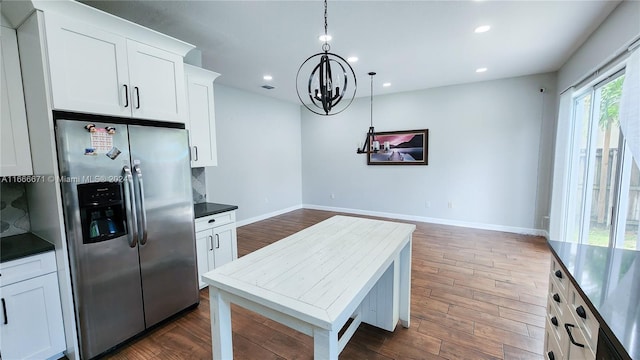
[367,129,429,165]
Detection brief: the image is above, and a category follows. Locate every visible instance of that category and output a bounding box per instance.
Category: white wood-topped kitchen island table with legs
[203,216,415,359]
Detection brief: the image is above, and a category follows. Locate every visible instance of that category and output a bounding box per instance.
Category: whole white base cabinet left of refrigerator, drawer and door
[0,251,66,360]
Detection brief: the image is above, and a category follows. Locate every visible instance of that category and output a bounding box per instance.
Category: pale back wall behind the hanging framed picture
[302,74,556,233]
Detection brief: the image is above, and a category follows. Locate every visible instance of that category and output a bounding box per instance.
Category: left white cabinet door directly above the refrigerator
[45,13,132,117]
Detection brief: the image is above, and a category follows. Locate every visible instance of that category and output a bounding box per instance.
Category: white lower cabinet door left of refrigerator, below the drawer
[0,273,66,359]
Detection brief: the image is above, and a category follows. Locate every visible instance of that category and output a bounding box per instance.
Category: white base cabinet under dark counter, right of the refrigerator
[195,211,238,289]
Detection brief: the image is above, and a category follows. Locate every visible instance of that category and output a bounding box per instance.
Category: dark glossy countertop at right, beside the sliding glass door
[549,240,640,359]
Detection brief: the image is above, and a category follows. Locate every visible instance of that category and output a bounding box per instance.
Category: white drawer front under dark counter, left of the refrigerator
[0,251,56,286]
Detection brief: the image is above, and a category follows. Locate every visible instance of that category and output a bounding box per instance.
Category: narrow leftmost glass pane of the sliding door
[565,92,592,242]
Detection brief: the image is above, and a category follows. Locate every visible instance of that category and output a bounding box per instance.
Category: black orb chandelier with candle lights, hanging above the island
[296,0,357,115]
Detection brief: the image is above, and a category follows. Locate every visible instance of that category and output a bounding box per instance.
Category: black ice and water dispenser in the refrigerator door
[78,182,127,244]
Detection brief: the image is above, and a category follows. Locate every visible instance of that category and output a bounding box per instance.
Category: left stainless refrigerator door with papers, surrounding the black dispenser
[56,120,144,359]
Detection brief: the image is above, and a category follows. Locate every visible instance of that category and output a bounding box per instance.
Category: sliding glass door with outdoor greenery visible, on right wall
[565,73,640,249]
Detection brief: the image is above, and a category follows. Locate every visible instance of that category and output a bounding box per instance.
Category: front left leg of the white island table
[209,285,233,360]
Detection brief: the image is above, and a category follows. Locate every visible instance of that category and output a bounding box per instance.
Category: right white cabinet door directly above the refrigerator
[127,40,187,123]
